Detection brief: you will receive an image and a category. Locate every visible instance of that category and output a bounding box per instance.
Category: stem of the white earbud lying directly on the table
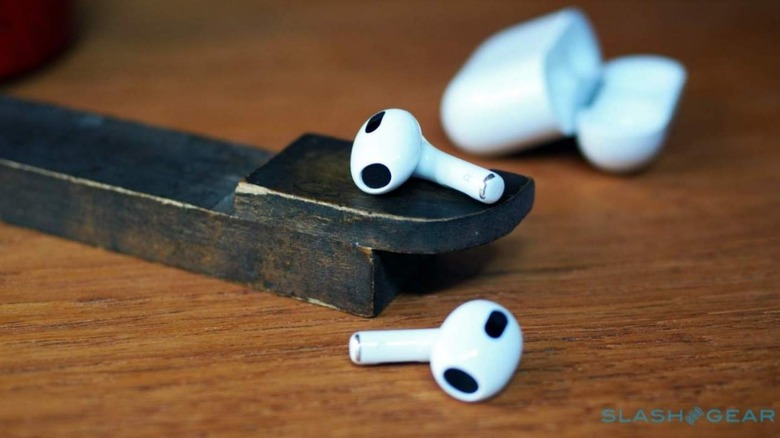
[349,328,440,365]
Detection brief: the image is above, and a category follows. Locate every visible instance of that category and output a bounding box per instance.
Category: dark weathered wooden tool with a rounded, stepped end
[0,97,534,317]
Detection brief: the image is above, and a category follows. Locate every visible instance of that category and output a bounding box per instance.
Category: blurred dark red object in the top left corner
[0,0,72,79]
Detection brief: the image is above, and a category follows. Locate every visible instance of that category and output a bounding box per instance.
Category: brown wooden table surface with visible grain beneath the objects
[0,0,780,437]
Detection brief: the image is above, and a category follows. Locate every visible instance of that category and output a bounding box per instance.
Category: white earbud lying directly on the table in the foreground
[349,300,523,402]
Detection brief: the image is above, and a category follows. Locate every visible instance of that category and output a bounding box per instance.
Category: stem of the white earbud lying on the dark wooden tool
[414,137,504,204]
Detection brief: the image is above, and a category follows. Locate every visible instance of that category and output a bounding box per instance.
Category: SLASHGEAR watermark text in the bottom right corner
[601,406,775,426]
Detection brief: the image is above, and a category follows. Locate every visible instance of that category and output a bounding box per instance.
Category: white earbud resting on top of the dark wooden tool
[350,109,504,204]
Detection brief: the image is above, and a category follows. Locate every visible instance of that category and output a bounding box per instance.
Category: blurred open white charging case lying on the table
[441,8,686,172]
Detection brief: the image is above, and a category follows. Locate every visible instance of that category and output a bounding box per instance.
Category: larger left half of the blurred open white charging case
[441,8,601,155]
